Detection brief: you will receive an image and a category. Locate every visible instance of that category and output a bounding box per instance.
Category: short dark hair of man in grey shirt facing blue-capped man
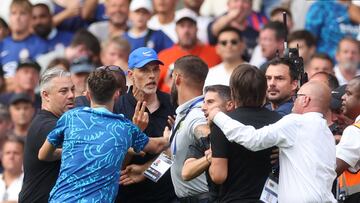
[174,55,209,89]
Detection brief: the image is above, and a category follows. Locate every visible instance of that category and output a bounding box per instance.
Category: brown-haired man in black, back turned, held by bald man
[209,64,281,202]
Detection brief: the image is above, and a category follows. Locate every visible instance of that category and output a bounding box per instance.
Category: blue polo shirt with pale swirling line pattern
[47,107,149,202]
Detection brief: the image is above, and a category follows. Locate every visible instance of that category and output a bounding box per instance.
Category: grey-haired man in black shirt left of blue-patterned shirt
[19,68,75,202]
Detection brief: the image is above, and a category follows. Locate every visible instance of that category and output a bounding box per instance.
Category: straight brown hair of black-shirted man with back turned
[230,64,267,107]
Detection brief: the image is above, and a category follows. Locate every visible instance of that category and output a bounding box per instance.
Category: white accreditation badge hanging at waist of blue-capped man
[144,152,174,183]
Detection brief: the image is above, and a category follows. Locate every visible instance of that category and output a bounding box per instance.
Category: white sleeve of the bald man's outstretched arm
[214,112,296,151]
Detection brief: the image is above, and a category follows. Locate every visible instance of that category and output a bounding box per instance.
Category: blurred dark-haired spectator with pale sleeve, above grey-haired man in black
[37,29,101,69]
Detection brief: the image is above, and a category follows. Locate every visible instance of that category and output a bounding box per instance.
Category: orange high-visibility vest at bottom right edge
[338,121,360,196]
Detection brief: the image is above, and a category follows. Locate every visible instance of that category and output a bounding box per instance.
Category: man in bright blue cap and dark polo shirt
[114,47,176,203]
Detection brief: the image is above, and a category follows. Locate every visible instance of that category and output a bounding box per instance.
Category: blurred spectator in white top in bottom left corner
[0,136,24,203]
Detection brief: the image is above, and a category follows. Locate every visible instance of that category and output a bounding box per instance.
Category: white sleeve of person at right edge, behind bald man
[336,126,360,167]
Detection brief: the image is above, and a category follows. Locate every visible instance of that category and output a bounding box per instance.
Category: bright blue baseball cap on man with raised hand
[129,47,164,69]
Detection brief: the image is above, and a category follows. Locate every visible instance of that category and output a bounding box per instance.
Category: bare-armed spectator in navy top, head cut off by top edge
[53,0,105,32]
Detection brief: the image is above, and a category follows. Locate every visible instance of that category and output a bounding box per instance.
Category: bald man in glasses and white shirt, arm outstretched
[209,81,336,202]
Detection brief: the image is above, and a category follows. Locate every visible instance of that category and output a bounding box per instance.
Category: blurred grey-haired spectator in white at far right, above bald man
[334,37,360,85]
